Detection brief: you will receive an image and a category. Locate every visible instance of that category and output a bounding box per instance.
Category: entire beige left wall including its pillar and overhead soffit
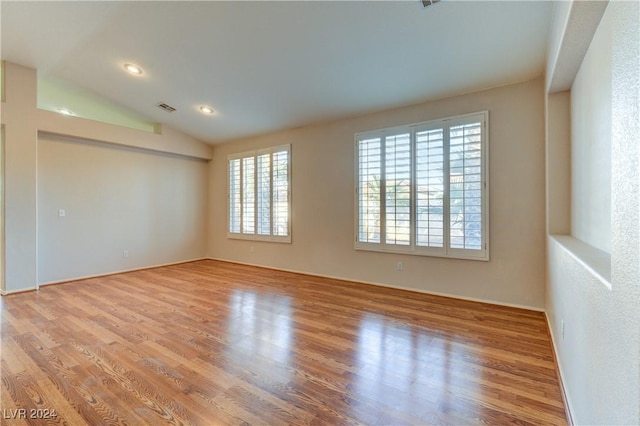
[1,63,212,294]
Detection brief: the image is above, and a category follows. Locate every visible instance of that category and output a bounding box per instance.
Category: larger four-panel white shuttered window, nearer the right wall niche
[356,112,489,260]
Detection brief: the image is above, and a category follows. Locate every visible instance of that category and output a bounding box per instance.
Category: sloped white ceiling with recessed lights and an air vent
[1,0,552,144]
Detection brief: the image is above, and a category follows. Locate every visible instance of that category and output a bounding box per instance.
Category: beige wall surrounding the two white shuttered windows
[209,79,545,309]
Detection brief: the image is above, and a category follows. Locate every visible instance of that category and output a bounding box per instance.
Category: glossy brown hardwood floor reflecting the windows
[0,261,566,425]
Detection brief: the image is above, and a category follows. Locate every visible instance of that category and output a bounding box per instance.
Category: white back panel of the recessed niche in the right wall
[571,11,611,252]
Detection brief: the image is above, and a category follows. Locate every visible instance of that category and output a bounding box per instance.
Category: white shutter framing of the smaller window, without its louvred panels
[226,144,291,243]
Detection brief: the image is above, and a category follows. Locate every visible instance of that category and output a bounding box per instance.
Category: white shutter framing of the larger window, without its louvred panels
[354,110,490,261]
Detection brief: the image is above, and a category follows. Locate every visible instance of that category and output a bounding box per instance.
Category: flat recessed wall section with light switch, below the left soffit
[38,135,207,284]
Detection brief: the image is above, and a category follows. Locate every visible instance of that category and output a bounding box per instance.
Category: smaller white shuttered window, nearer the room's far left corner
[227,145,291,242]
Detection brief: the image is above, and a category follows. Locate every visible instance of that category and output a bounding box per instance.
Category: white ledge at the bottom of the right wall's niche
[549,235,611,290]
